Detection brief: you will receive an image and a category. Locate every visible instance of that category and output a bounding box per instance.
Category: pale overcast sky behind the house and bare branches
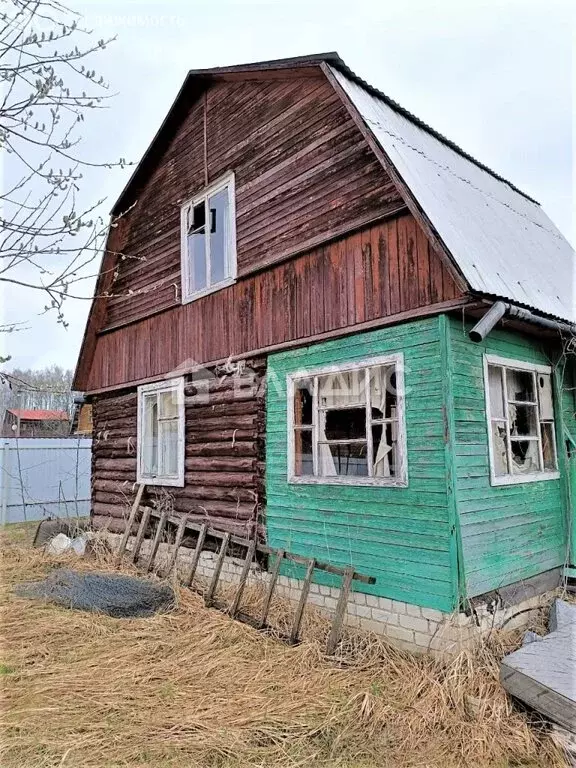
[0,0,576,374]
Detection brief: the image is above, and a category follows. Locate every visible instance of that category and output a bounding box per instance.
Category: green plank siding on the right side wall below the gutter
[448,319,566,597]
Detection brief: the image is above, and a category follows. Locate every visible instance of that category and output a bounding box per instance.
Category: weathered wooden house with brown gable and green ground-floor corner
[73,54,576,647]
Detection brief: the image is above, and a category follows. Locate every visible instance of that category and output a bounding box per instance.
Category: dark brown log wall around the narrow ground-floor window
[92,359,266,537]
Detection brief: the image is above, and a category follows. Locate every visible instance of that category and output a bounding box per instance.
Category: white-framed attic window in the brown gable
[180,174,236,302]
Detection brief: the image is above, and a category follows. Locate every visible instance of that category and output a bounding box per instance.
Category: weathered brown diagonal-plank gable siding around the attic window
[100,70,401,327]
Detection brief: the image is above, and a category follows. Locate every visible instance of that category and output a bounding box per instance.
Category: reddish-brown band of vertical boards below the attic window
[84,214,460,391]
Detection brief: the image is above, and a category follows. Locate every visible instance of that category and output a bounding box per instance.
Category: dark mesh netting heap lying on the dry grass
[14,568,175,619]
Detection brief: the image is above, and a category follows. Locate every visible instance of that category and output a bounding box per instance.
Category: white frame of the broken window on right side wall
[484,355,560,486]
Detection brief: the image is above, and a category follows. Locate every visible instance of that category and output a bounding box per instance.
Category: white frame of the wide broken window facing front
[286,353,408,488]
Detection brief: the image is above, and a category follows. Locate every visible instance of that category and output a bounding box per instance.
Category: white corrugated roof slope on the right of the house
[332,63,576,321]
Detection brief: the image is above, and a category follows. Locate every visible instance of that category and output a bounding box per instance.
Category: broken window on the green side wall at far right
[486,357,557,483]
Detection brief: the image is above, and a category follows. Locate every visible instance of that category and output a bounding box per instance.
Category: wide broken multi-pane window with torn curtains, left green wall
[292,362,406,483]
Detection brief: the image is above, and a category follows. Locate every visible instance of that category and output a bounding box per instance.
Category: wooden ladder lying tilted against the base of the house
[116,485,376,656]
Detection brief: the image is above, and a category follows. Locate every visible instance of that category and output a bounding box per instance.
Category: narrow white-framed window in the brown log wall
[138,379,184,485]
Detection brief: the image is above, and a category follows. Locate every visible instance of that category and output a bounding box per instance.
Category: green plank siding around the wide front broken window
[266,318,458,611]
